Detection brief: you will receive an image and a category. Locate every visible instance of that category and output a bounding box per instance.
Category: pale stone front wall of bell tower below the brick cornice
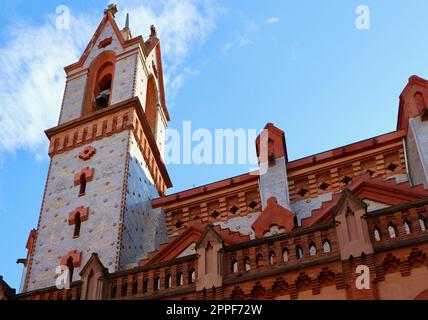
[26,131,129,291]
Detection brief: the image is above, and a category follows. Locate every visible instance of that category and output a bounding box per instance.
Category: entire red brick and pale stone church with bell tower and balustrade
[0,5,428,300]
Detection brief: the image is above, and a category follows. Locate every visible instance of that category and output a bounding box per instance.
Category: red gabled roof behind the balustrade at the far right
[302,174,428,227]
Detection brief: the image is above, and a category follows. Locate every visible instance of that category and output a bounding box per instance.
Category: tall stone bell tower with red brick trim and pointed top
[22,5,172,291]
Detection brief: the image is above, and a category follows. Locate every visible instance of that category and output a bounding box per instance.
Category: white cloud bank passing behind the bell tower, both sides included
[0,0,221,158]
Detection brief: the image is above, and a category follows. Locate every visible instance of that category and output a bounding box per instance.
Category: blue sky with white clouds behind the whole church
[0,0,428,287]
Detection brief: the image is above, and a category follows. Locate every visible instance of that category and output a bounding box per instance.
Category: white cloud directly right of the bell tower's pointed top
[117,0,223,101]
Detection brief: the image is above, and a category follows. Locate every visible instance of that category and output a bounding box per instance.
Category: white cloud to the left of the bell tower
[0,16,96,153]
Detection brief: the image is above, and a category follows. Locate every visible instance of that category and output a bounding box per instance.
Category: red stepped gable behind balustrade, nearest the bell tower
[139,221,250,267]
